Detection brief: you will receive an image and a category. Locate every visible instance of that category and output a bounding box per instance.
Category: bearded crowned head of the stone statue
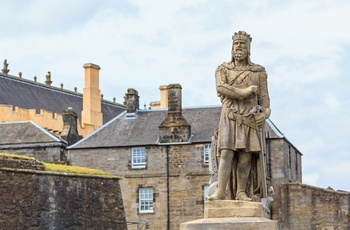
[231,31,252,63]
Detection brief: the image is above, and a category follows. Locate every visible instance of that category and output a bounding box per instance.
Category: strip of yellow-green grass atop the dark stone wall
[0,153,113,176]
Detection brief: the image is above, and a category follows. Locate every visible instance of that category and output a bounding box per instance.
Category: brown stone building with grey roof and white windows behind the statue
[68,84,301,229]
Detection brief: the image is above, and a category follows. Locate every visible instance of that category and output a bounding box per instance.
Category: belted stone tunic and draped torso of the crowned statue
[215,62,270,154]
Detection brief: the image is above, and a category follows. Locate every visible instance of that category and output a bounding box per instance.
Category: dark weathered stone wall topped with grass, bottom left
[0,159,127,230]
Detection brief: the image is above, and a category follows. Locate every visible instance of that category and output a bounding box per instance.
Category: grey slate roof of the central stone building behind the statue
[69,106,221,149]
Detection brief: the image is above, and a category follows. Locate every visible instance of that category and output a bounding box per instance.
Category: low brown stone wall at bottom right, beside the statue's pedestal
[275,183,350,230]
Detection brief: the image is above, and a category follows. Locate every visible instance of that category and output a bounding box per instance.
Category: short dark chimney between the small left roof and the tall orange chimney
[61,107,80,145]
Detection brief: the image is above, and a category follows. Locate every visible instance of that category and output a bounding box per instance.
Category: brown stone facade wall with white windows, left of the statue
[69,144,210,230]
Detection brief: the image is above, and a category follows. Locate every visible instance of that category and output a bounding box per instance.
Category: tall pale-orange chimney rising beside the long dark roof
[81,63,103,128]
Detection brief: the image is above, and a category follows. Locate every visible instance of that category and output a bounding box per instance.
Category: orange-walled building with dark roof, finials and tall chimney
[0,60,125,137]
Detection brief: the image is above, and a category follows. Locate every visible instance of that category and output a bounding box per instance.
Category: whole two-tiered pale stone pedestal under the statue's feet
[180,200,278,230]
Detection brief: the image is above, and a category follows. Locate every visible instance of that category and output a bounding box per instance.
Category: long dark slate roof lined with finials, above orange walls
[0,74,125,123]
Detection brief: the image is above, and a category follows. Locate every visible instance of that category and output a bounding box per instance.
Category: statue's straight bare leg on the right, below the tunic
[236,152,252,201]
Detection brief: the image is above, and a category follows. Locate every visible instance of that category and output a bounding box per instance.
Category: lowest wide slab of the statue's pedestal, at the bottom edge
[180,217,278,230]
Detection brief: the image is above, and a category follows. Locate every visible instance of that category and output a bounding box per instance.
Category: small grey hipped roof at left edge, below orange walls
[0,121,66,146]
